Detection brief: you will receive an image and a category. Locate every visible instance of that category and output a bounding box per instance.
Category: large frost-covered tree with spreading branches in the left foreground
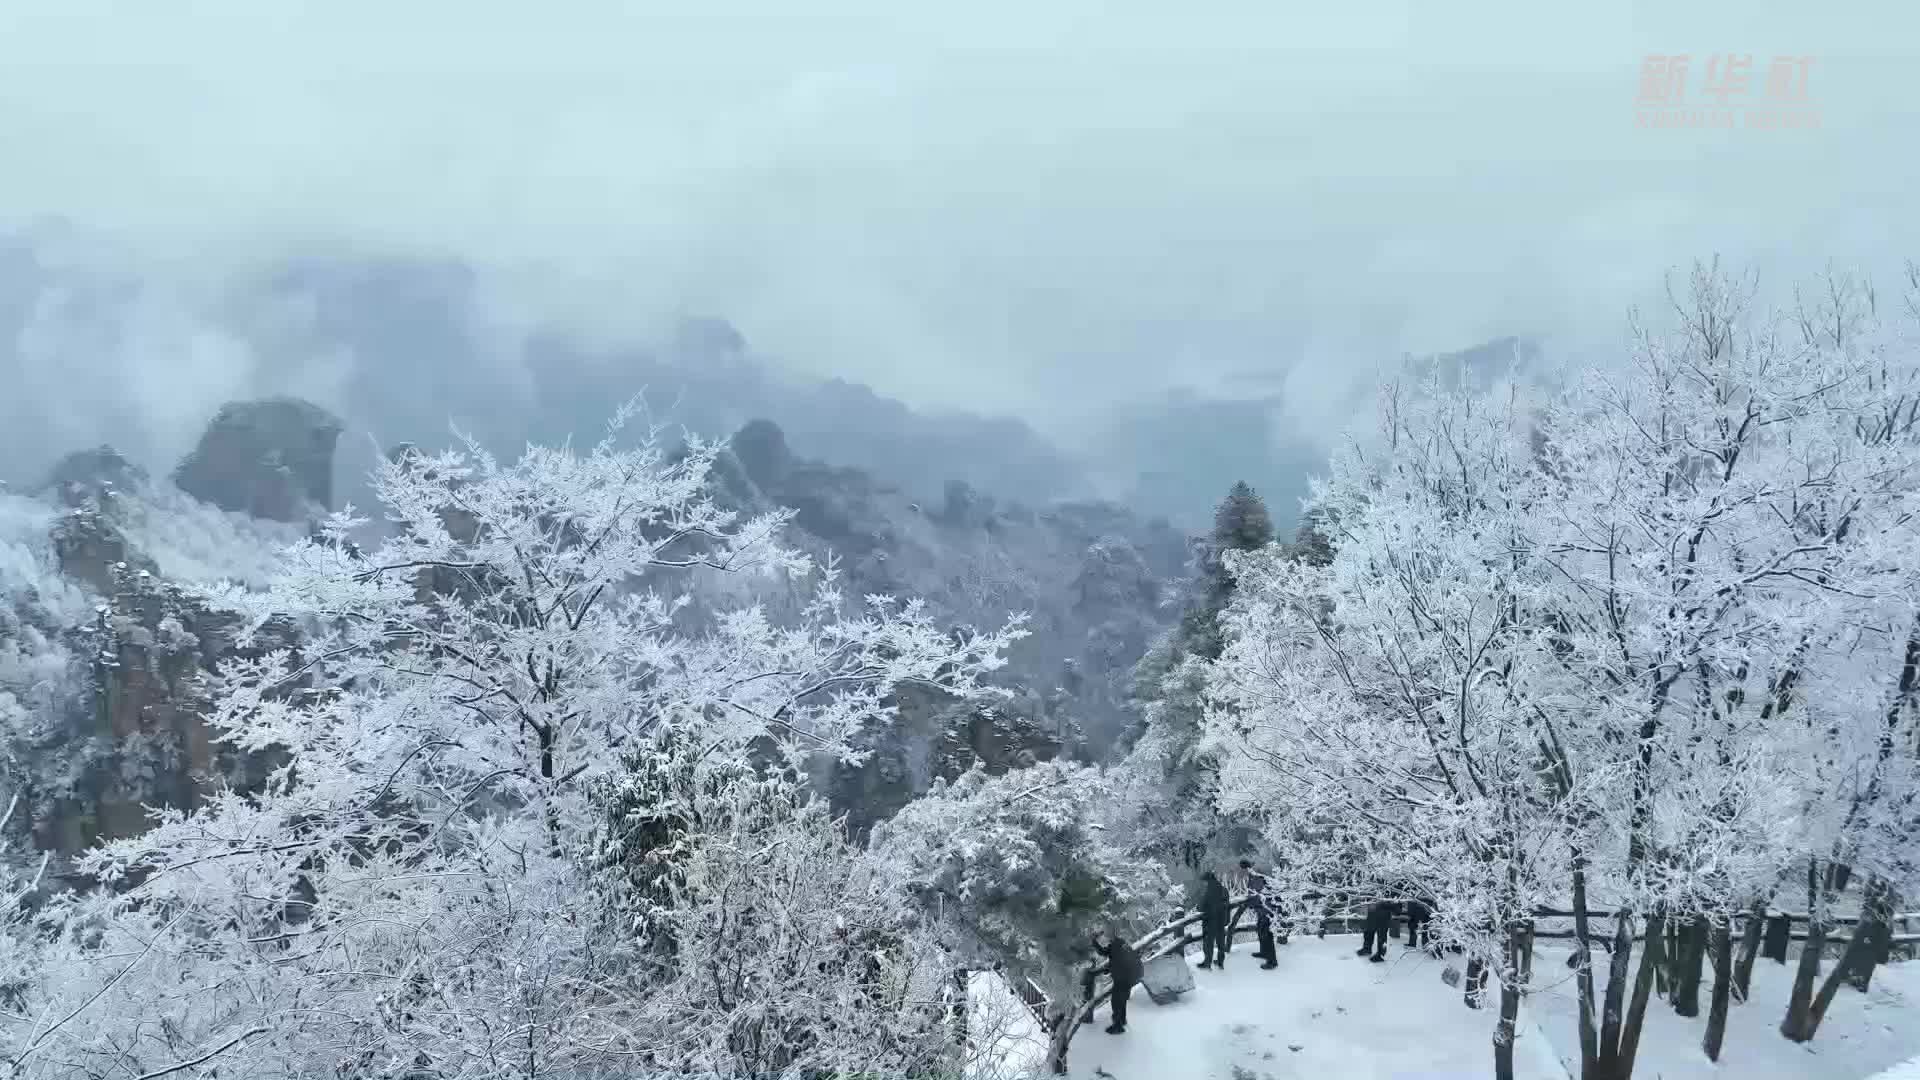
[0,407,1018,1080]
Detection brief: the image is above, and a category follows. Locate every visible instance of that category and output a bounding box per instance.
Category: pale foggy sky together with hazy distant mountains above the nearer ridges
[0,0,1920,523]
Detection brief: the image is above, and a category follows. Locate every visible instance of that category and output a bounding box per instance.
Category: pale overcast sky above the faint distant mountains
[0,0,1920,445]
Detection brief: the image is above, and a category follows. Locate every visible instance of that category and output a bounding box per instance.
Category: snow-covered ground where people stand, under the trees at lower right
[1068,936,1920,1080]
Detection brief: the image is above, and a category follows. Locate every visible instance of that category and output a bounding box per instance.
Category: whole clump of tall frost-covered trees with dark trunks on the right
[1210,267,1920,1080]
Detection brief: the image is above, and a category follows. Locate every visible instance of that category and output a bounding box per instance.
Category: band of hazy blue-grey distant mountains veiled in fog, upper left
[0,238,1113,503]
